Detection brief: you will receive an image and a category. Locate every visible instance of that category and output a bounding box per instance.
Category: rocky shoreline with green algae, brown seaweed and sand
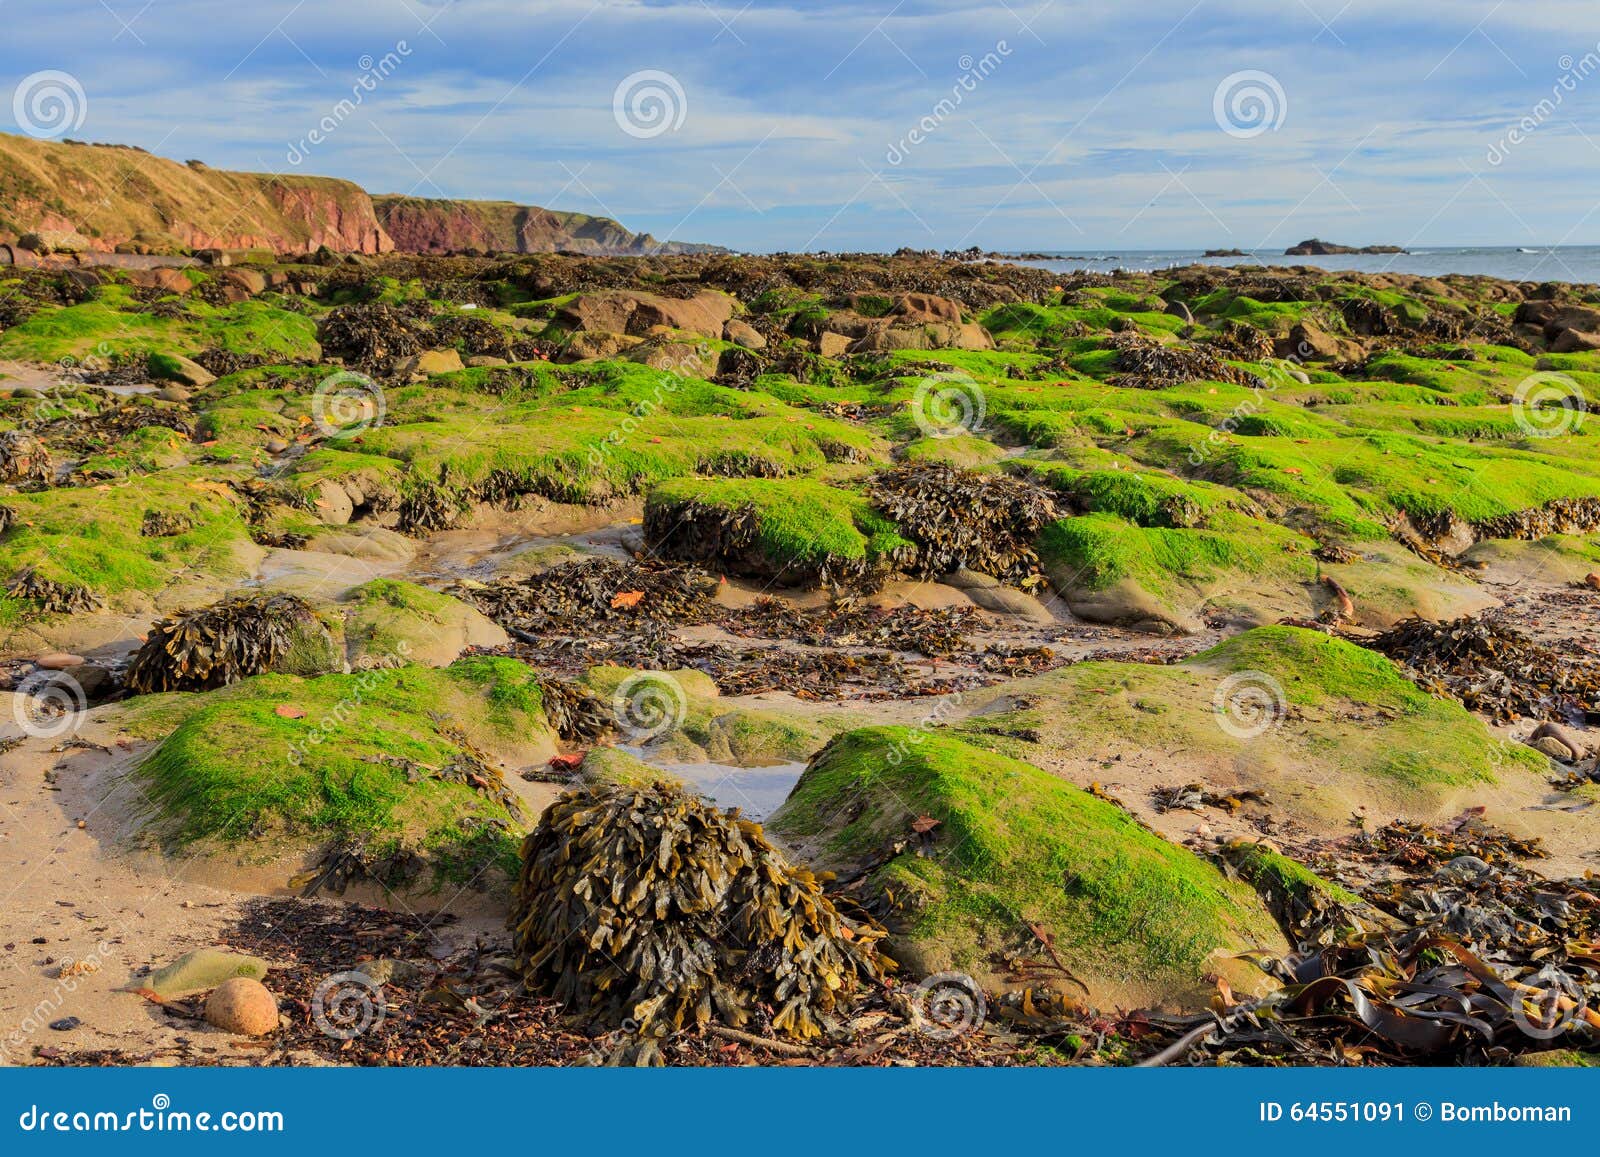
[0,251,1600,1064]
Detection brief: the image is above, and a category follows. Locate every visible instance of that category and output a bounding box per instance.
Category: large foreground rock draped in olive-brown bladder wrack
[509,783,883,1040]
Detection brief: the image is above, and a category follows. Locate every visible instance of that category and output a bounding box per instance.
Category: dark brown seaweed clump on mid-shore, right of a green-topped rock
[870,464,1059,586]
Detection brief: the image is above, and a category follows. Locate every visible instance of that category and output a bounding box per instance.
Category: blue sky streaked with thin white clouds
[0,0,1600,253]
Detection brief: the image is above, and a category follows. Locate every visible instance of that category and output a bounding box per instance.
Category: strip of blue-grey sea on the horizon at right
[1019,245,1600,285]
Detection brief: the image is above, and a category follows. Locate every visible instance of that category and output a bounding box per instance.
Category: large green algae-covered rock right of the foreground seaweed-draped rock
[770,727,1282,1007]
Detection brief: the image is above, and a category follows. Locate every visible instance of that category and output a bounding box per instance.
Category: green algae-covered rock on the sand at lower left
[118,658,555,887]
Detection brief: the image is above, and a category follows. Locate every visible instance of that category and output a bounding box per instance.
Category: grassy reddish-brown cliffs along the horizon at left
[0,133,715,254]
